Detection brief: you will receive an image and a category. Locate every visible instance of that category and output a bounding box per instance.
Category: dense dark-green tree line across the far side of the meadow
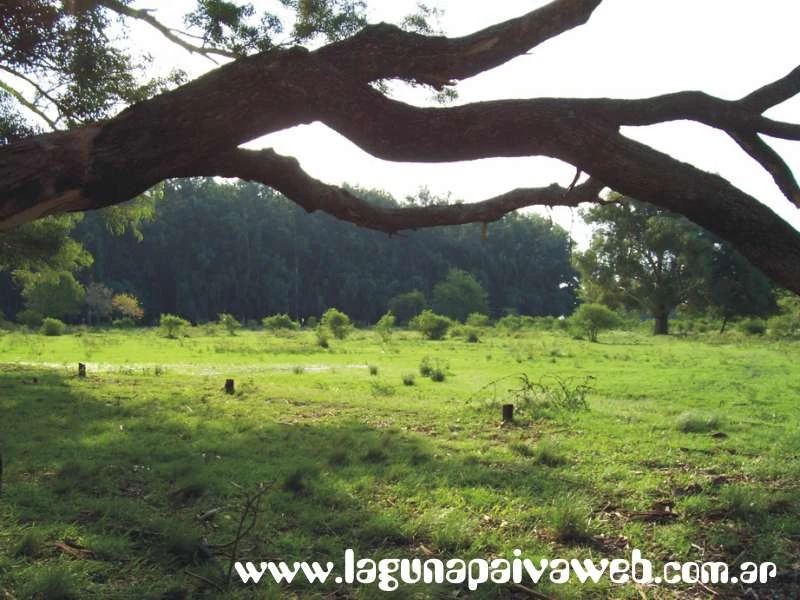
[57,179,576,323]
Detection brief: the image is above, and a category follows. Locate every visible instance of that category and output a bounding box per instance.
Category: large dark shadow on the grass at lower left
[0,369,796,600]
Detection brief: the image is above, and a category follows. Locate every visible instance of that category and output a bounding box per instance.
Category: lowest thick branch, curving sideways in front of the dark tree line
[182,148,604,234]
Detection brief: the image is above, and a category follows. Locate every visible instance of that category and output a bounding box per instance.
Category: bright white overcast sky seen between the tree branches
[128,0,800,241]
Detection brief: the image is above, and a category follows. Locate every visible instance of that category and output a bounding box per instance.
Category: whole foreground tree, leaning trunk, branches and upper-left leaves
[0,0,800,292]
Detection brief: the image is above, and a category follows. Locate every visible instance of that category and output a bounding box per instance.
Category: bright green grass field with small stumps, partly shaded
[0,328,800,600]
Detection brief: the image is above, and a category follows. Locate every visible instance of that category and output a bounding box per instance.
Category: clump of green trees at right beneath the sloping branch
[576,196,774,334]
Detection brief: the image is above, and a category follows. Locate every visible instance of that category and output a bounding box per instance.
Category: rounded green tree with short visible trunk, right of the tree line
[576,198,710,335]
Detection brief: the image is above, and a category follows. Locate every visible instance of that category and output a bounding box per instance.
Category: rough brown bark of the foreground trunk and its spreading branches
[0,0,800,293]
